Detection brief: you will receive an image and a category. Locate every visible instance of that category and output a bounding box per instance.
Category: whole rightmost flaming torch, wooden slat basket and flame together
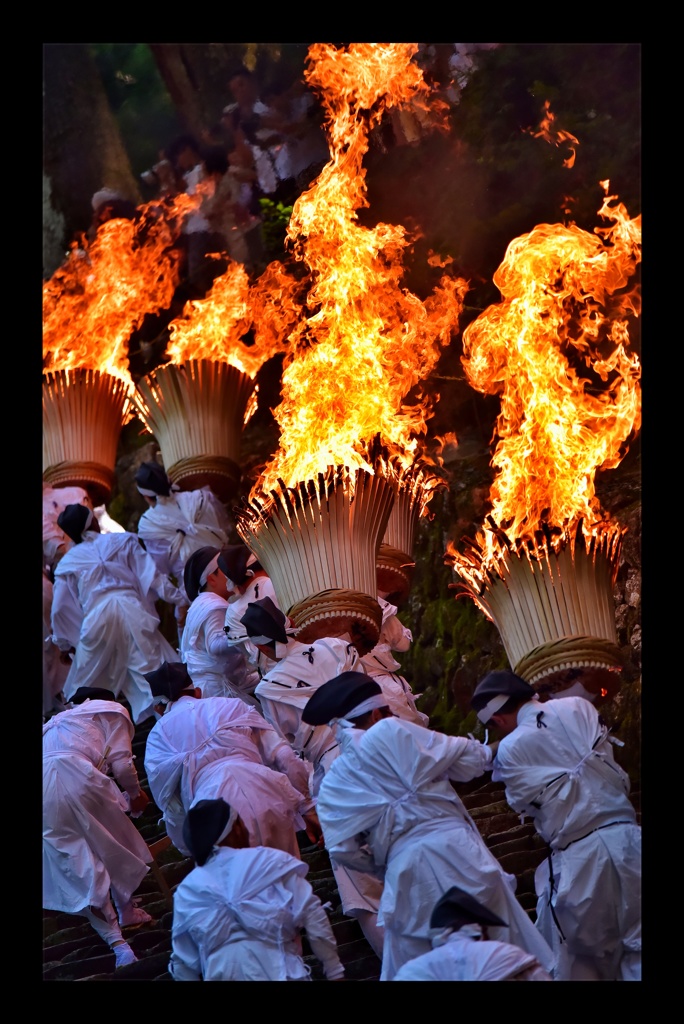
[446,181,641,696]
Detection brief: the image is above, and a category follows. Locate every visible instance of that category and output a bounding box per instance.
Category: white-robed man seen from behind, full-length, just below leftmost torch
[52,505,182,725]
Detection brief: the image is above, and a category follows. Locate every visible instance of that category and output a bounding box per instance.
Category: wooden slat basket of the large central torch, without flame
[236,466,394,654]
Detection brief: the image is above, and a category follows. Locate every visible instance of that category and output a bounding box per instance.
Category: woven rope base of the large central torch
[288,589,382,657]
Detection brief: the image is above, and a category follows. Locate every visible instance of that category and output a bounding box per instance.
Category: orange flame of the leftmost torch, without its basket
[43,194,198,391]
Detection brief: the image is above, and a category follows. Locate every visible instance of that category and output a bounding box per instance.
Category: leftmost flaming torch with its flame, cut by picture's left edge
[43,196,197,505]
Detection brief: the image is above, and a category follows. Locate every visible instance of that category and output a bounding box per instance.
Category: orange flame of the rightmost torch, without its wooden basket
[447,181,641,574]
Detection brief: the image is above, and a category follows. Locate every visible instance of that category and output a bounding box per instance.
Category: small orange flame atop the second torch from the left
[166,260,301,378]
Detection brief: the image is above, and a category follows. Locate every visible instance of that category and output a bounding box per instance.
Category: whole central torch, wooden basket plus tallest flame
[236,43,466,653]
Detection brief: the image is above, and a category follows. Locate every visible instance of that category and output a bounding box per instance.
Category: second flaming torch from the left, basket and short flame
[135,261,300,502]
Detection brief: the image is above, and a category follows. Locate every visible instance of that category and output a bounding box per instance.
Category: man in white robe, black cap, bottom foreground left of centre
[169,799,344,981]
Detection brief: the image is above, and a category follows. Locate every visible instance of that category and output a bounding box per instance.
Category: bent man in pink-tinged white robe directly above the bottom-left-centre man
[144,664,320,857]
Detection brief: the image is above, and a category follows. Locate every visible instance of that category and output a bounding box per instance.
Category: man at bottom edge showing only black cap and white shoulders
[392,886,553,981]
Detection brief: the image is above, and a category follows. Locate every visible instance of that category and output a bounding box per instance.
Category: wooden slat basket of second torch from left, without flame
[134,359,256,502]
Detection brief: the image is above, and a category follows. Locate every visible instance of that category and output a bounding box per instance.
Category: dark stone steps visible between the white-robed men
[43,720,640,981]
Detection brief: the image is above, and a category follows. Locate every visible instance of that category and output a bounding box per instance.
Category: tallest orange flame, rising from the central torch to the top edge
[252,43,468,496]
